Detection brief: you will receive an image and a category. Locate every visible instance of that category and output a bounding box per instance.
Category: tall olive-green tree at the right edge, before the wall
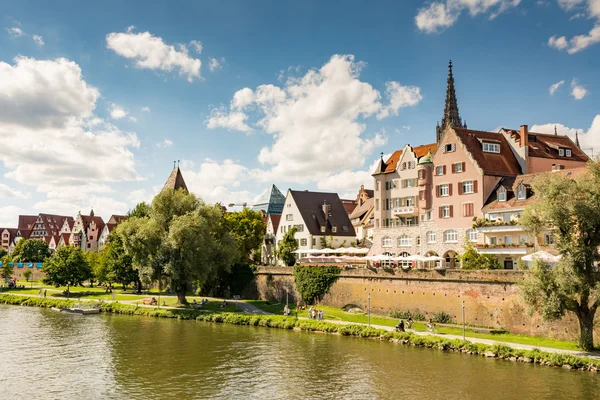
[519,162,600,351]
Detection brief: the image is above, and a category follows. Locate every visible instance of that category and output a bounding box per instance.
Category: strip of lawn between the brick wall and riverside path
[248,300,581,350]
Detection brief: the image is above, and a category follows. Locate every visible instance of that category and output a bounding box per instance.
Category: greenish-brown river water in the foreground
[0,305,600,400]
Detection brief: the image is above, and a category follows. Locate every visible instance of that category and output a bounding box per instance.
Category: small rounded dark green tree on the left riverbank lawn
[42,246,92,290]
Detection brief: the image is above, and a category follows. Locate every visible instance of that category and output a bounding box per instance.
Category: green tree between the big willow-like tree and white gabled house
[225,208,267,263]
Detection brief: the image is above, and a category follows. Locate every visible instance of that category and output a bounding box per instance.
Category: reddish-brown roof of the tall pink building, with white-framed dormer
[454,128,521,176]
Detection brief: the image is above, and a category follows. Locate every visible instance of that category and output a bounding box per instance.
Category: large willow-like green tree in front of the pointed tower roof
[118,189,239,304]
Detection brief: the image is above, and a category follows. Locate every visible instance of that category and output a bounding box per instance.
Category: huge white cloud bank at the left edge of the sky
[0,57,140,209]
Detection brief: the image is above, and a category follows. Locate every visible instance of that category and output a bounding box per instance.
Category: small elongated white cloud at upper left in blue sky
[106,30,202,82]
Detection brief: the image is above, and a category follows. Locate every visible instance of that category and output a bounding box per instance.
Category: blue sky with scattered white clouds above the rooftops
[0,0,600,227]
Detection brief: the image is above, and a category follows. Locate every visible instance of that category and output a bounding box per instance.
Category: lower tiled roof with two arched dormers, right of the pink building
[483,167,587,211]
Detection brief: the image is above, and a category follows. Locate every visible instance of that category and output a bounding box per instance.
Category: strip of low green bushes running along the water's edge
[0,294,600,372]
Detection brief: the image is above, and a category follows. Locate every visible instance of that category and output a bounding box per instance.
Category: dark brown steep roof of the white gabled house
[290,190,355,236]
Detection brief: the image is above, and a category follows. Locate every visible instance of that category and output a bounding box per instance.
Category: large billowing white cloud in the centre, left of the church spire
[207,55,412,183]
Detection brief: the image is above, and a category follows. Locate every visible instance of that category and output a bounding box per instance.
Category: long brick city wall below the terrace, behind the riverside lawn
[253,267,600,343]
